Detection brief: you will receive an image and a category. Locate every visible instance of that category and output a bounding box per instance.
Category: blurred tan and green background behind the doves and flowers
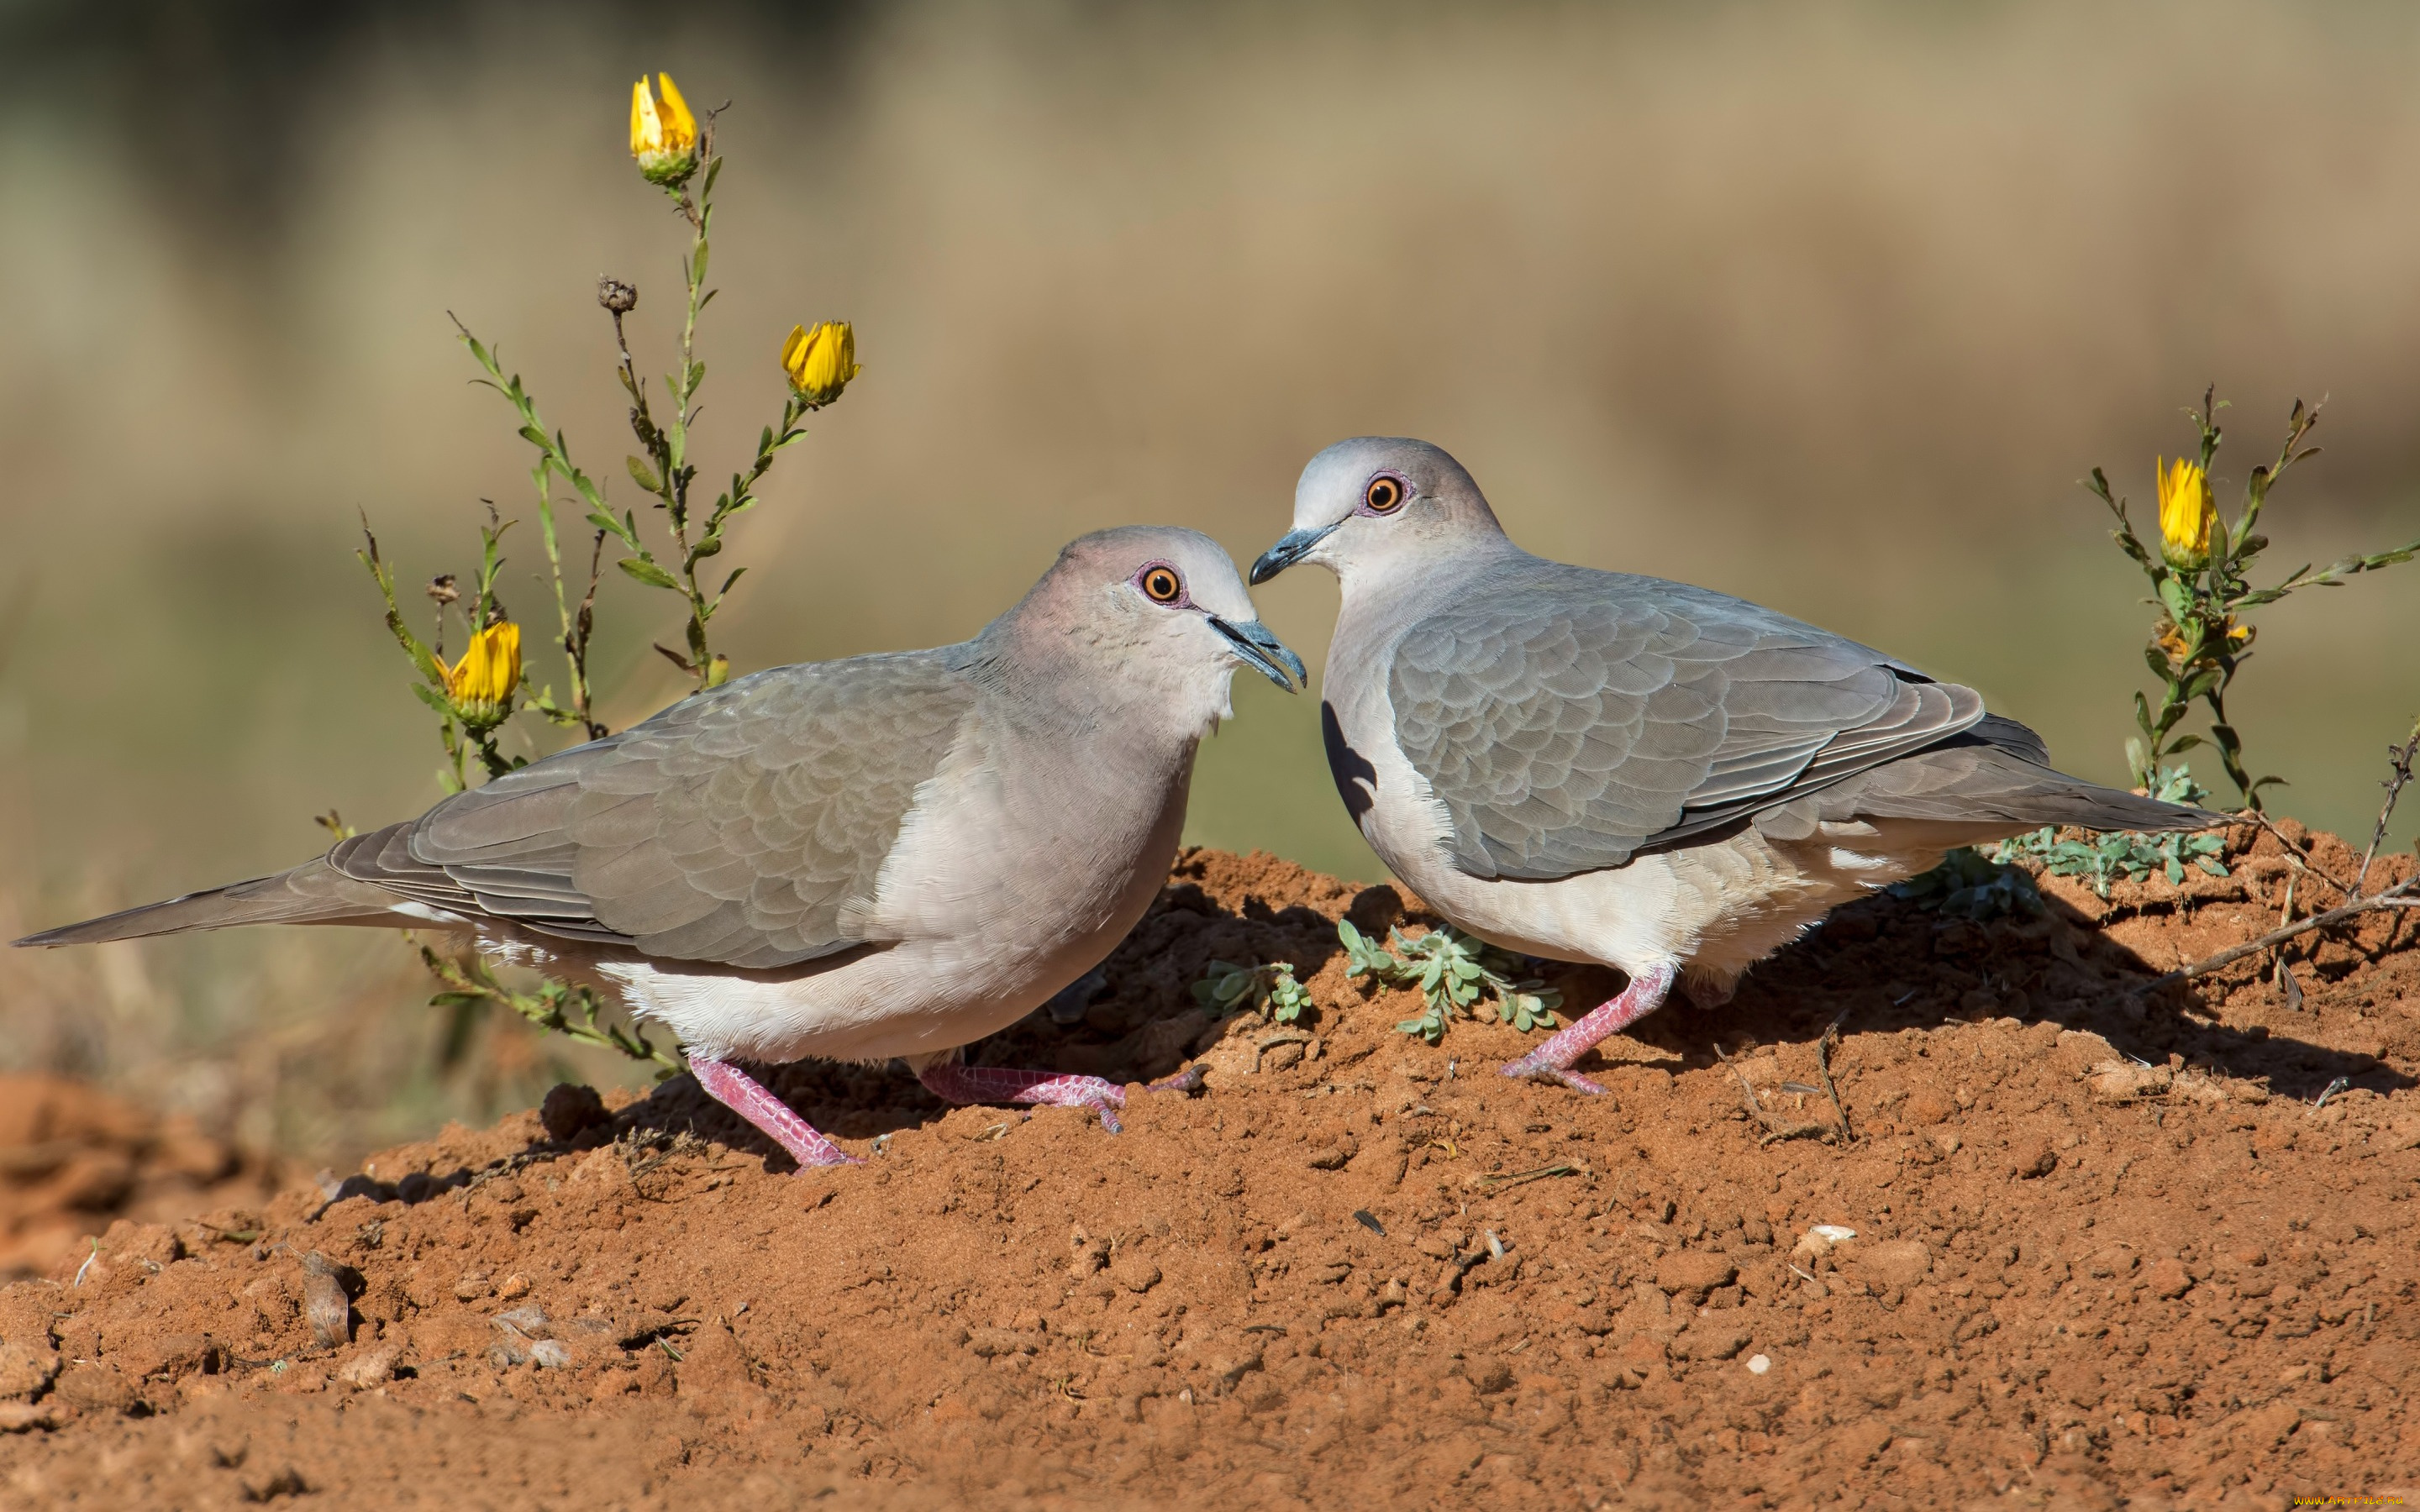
[0,0,2420,1159]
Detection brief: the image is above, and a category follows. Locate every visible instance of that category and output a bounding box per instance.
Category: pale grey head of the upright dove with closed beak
[1251,435,1507,583]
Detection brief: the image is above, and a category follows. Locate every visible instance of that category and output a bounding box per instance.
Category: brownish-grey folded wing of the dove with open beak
[329,648,978,968]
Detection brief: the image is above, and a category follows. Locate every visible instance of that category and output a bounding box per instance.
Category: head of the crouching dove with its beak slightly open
[985,525,1304,726]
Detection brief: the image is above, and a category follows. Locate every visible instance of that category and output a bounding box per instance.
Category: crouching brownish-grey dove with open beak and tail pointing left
[17,528,1304,1166]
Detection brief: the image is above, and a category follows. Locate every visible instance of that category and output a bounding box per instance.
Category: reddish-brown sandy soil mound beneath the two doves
[0,825,2420,1509]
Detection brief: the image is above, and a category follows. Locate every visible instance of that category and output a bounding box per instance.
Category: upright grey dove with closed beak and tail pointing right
[1251,435,2217,1094]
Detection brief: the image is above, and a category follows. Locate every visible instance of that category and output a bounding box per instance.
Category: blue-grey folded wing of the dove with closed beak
[1386,559,1985,880]
